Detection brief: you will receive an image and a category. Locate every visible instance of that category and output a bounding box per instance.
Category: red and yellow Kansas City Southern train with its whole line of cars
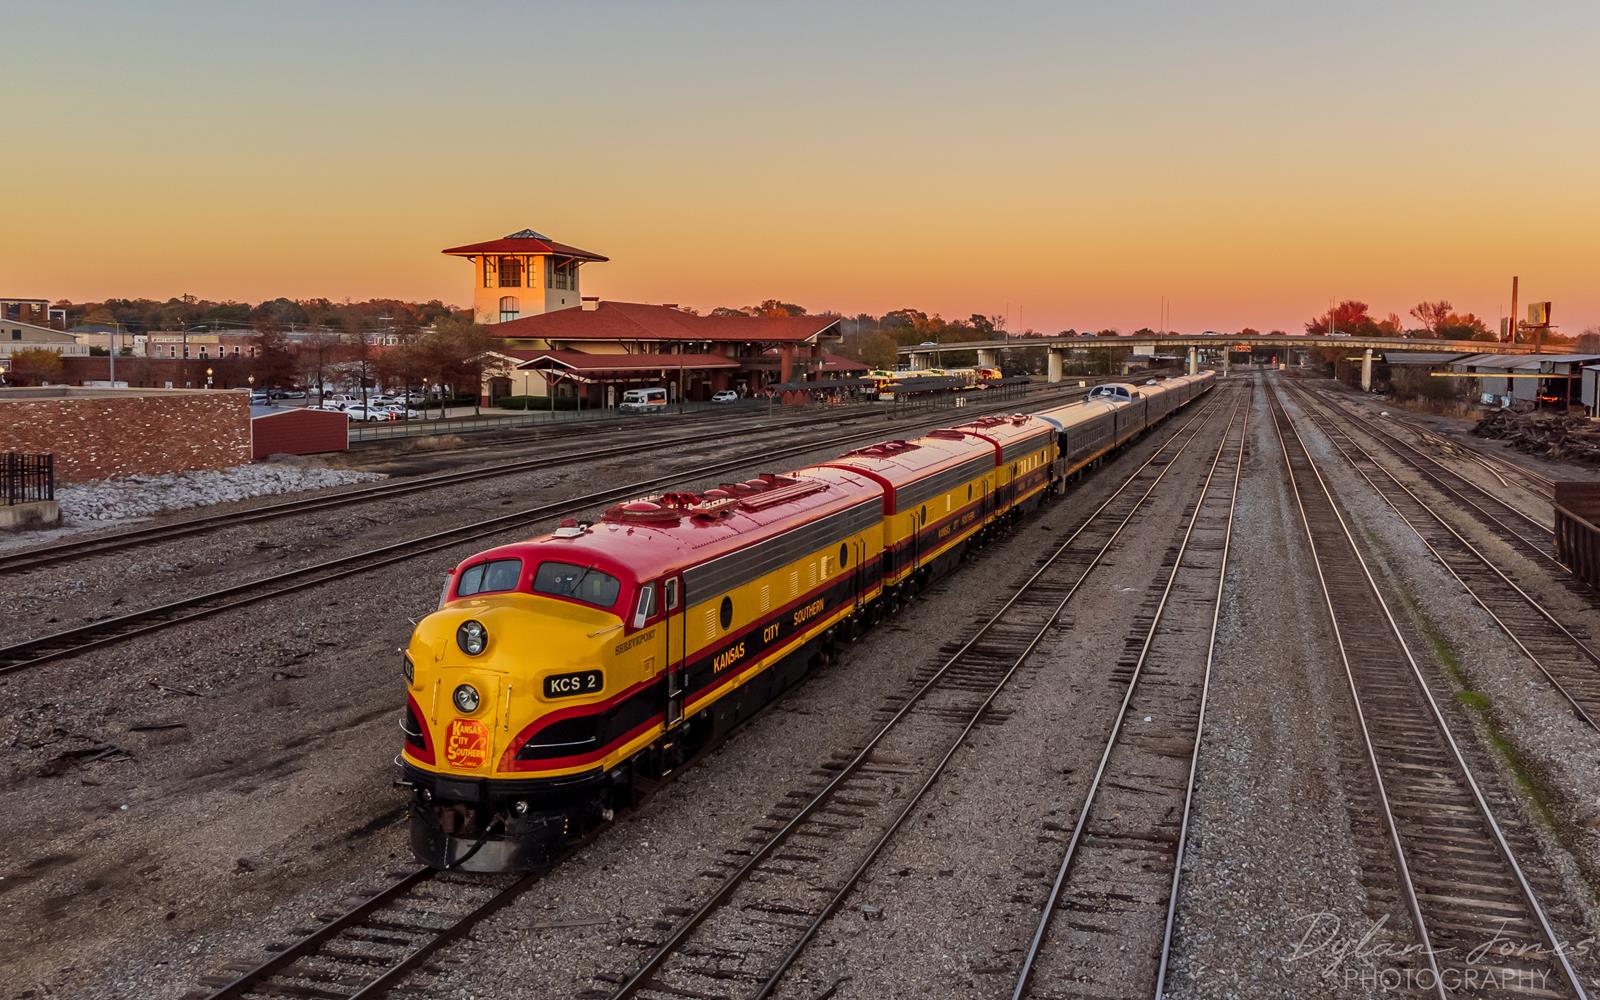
[400,366,1214,872]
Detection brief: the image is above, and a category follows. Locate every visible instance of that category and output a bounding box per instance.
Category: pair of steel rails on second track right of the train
[1011,385,1250,1000]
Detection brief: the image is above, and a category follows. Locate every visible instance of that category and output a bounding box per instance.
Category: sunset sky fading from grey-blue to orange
[0,0,1600,331]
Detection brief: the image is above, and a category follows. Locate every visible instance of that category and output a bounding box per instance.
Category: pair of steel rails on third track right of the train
[1270,380,1587,1000]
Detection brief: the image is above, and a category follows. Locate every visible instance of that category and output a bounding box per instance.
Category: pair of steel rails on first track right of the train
[611,384,1214,1000]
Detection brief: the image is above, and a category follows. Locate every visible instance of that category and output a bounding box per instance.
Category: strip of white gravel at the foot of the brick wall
[56,462,384,522]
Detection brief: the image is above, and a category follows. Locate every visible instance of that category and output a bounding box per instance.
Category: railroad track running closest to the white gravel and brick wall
[0,389,1082,574]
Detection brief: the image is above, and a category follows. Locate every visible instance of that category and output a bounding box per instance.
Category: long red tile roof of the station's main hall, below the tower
[490,302,838,344]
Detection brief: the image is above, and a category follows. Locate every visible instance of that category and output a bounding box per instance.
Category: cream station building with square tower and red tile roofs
[443,229,866,408]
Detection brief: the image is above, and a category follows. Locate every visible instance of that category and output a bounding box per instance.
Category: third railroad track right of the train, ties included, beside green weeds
[1270,380,1587,1000]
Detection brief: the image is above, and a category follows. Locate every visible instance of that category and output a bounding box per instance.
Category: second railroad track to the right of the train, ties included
[1011,389,1253,1000]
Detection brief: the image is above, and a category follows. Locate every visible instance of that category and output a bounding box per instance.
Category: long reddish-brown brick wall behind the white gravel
[0,389,250,483]
